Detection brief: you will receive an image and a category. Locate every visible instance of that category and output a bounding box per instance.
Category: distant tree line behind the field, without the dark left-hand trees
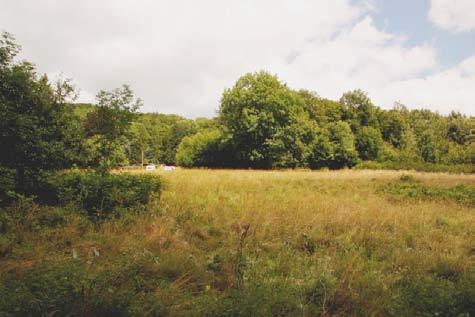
[73,72,473,169]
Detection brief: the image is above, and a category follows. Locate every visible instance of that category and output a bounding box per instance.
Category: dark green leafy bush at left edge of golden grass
[43,171,163,219]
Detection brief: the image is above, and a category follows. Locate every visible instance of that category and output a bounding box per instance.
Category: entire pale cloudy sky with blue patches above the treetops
[0,0,475,117]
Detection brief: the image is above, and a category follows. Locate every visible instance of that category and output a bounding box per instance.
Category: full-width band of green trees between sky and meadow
[0,33,473,199]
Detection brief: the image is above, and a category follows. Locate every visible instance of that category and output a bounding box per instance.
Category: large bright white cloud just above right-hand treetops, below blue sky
[282,17,475,115]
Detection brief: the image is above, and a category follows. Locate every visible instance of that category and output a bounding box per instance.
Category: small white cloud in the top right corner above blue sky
[429,0,475,32]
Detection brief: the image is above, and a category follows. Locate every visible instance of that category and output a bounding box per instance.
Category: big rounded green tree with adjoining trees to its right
[170,72,471,171]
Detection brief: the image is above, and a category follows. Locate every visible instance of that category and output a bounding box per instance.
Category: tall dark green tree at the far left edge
[0,33,78,196]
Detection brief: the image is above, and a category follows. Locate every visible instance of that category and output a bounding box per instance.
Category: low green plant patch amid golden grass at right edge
[382,176,475,206]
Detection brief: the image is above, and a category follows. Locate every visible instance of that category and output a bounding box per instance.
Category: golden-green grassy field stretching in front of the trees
[0,169,475,316]
